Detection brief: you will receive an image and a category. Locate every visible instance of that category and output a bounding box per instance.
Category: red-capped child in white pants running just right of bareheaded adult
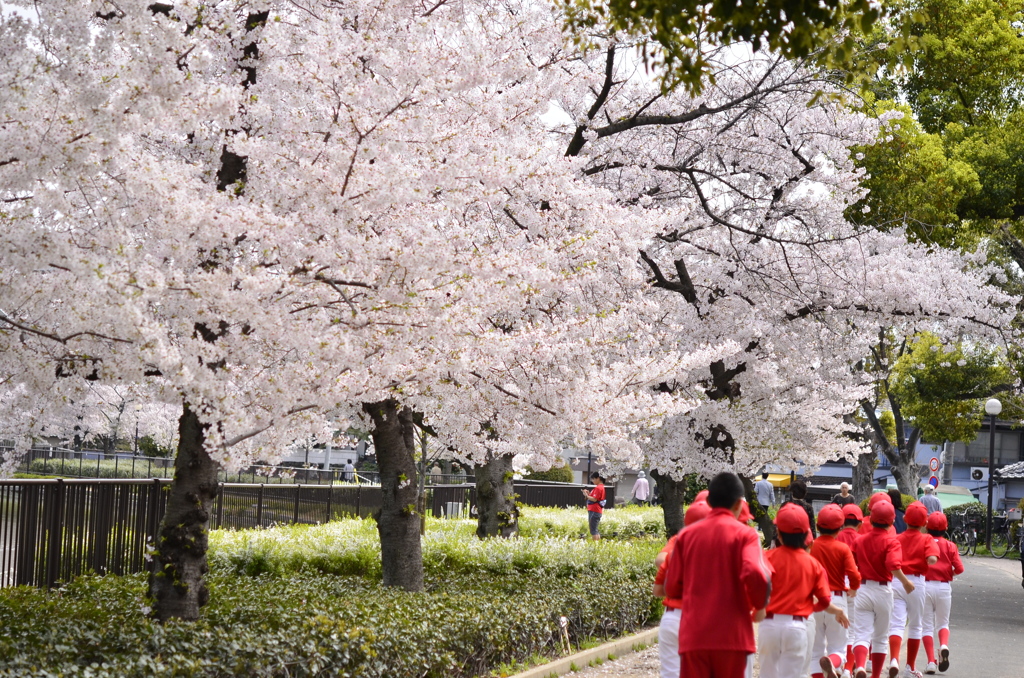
[758,504,850,678]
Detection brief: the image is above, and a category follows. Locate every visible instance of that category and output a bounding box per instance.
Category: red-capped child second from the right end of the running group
[889,502,939,678]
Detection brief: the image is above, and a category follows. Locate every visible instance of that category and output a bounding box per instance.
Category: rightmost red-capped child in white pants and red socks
[925,511,964,674]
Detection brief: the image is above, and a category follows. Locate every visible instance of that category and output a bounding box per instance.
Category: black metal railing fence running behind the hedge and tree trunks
[0,478,614,587]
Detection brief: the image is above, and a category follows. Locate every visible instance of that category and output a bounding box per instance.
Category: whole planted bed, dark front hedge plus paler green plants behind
[0,519,660,678]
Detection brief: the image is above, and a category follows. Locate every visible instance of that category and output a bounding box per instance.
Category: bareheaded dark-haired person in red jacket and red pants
[665,472,771,678]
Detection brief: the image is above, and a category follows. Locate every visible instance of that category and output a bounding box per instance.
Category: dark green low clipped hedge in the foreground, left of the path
[0,567,657,678]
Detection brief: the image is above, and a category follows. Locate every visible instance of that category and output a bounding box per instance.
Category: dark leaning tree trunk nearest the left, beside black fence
[150,402,219,622]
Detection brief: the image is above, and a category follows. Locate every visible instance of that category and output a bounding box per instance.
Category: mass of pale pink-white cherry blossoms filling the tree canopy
[0,0,1012,472]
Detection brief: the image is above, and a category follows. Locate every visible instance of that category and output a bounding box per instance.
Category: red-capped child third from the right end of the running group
[853,501,913,678]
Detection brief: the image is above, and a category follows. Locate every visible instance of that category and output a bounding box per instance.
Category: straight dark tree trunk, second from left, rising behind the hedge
[362,400,423,591]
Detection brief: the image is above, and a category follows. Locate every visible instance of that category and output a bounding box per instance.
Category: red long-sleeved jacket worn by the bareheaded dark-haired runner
[665,508,771,652]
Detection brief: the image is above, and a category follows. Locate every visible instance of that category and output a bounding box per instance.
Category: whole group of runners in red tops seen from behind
[654,473,964,678]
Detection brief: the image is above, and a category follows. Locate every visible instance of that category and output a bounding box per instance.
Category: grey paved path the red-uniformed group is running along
[569,557,1024,678]
